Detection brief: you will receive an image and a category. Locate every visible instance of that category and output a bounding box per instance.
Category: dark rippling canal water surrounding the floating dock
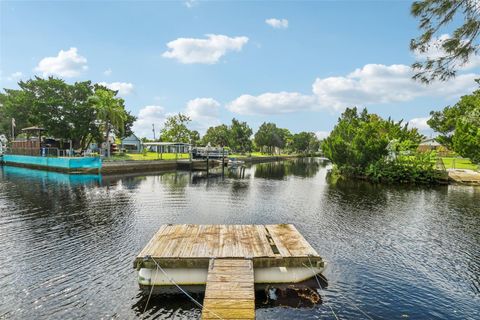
[0,159,480,319]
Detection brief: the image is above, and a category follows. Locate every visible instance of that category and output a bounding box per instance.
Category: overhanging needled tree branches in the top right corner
[410,0,480,83]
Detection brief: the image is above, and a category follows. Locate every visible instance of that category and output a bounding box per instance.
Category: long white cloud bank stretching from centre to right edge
[227,64,479,114]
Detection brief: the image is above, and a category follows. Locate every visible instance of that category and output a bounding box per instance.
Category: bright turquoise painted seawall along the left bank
[3,154,102,169]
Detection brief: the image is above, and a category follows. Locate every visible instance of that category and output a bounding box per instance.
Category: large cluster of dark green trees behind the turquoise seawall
[0,77,136,151]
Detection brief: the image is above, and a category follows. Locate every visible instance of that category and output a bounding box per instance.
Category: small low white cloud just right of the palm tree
[132,106,167,138]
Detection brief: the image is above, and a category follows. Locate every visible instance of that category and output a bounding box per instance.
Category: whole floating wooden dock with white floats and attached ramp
[134,224,325,319]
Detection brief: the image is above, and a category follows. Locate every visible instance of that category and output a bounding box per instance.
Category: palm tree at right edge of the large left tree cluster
[89,88,127,157]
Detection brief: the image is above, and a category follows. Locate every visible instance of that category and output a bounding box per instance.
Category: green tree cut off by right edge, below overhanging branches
[427,86,480,163]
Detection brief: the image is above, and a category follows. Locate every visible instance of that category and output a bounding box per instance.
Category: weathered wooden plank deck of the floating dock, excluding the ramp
[134,224,321,268]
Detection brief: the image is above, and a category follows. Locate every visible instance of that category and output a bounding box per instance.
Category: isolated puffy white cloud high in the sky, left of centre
[162,34,248,64]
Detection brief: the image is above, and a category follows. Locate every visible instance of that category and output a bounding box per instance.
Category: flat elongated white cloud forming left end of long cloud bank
[227,92,317,115]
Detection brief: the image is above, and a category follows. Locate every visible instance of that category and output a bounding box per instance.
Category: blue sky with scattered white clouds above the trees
[0,0,480,138]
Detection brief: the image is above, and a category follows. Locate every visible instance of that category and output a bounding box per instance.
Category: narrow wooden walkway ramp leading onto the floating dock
[202,259,255,319]
